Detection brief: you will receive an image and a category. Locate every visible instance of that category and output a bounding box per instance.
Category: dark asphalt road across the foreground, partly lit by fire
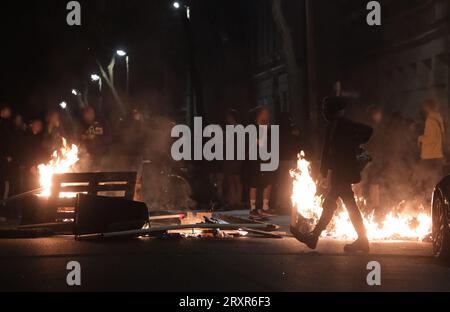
[0,237,450,292]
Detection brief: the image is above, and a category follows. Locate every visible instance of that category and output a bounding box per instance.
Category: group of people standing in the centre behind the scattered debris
[209,106,304,217]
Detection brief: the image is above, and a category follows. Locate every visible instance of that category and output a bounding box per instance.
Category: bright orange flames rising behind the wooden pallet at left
[38,138,79,197]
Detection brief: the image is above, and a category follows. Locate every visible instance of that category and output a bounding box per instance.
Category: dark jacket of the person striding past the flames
[321,117,373,184]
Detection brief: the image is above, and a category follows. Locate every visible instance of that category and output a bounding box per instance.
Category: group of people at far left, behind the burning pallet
[0,105,151,216]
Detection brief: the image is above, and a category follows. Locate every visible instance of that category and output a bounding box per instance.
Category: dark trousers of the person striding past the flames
[314,178,367,239]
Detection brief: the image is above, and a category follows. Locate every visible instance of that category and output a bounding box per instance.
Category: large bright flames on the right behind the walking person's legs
[291,152,432,240]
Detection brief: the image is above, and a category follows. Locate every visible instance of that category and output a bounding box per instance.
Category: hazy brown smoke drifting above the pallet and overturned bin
[76,91,196,211]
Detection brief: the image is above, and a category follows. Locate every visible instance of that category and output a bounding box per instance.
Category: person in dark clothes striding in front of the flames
[292,97,373,252]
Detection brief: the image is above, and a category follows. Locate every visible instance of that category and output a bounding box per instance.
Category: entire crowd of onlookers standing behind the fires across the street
[0,96,446,225]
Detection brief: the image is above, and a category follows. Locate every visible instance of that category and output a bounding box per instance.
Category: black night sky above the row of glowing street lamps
[0,0,253,119]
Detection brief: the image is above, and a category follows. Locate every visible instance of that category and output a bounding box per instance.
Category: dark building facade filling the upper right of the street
[250,0,450,151]
